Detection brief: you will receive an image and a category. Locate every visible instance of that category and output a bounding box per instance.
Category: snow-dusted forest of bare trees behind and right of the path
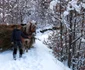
[0,0,85,70]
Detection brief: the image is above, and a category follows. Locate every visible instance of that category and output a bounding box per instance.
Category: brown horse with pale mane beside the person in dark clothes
[23,20,36,52]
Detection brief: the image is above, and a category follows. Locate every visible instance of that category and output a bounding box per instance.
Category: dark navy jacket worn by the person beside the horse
[11,29,28,42]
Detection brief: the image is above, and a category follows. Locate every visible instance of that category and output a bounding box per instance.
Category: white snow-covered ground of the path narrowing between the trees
[0,29,70,70]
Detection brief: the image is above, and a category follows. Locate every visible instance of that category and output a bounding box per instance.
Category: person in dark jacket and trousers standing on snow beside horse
[11,25,29,60]
